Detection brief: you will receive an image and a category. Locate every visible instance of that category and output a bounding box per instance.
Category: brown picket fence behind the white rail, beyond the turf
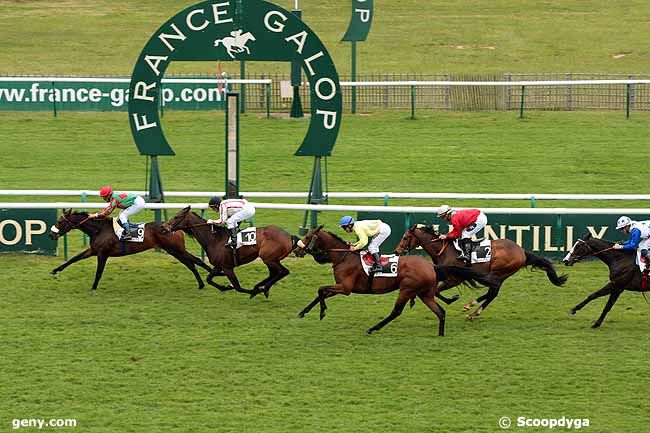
[233,73,650,113]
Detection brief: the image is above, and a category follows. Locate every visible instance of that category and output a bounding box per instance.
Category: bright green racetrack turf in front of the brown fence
[0,109,650,433]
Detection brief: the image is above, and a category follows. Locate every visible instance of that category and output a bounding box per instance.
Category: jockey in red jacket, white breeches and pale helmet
[438,204,487,266]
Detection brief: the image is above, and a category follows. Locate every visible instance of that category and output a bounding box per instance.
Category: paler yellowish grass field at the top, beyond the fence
[0,0,650,75]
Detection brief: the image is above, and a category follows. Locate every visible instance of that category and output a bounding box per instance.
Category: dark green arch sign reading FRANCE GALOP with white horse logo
[129,0,342,157]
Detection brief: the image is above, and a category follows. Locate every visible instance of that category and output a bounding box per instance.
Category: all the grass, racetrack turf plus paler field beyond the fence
[0,0,650,433]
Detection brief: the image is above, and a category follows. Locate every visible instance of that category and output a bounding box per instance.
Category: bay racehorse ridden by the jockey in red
[395,224,568,319]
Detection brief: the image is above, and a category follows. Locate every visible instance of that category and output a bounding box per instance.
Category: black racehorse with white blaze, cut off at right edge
[562,233,647,328]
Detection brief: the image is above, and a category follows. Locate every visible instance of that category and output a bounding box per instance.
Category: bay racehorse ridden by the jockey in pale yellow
[294,226,494,336]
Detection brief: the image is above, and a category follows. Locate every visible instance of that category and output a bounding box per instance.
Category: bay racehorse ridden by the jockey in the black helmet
[163,206,297,298]
